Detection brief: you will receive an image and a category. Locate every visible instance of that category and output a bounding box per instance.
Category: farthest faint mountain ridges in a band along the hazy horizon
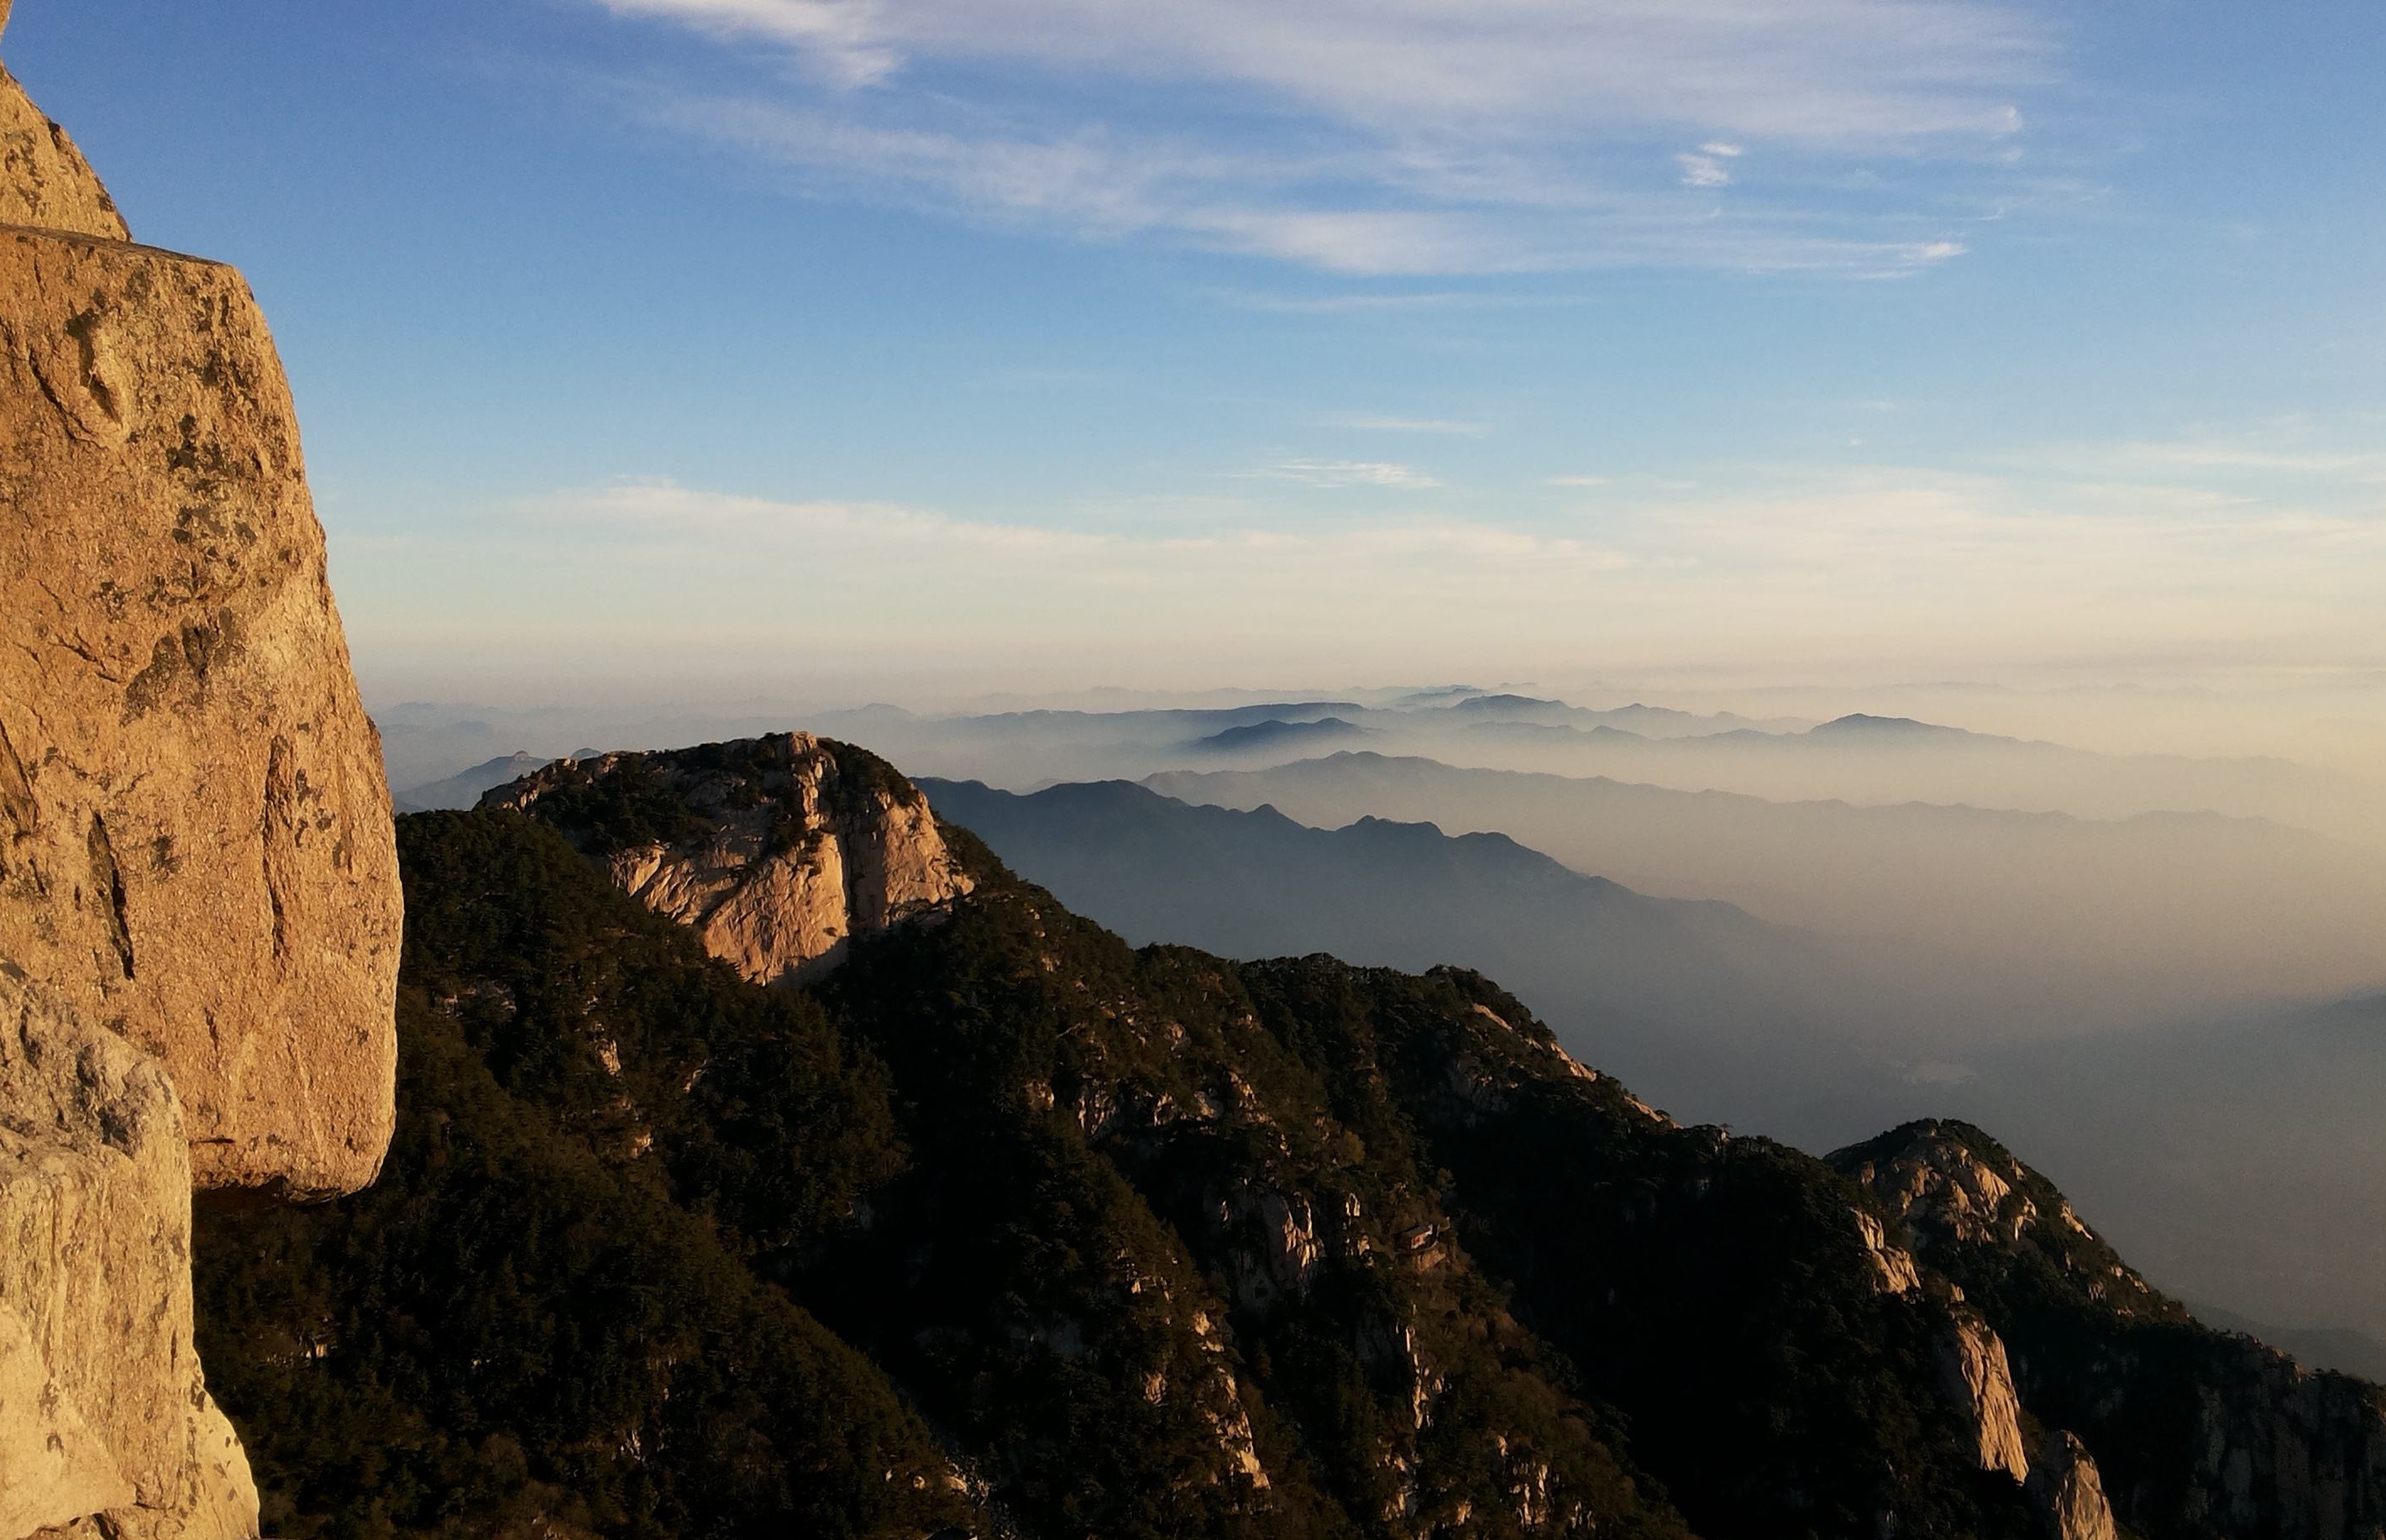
[382,689,2386,853]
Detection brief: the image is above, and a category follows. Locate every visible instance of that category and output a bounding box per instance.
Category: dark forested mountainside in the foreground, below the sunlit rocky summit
[198,744,2369,1540]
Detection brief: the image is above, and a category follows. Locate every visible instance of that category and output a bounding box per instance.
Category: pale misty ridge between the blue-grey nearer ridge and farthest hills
[1146,751,2386,1032]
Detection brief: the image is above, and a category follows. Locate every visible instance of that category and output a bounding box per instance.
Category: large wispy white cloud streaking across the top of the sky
[592,0,2057,274]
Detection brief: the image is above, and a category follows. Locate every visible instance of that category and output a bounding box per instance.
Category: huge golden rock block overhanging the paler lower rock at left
[0,231,401,1197]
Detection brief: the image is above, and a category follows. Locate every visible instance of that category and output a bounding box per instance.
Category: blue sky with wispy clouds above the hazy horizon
[5,0,2386,694]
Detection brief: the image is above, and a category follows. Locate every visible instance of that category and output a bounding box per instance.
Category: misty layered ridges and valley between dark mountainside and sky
[380,687,2386,1352]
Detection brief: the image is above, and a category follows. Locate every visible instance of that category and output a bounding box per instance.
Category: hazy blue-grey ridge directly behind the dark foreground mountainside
[919,779,1860,1120]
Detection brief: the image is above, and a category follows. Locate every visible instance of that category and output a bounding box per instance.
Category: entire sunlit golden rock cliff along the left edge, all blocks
[0,5,398,1540]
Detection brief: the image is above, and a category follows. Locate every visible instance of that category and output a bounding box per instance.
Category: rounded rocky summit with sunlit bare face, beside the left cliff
[482,732,971,985]
